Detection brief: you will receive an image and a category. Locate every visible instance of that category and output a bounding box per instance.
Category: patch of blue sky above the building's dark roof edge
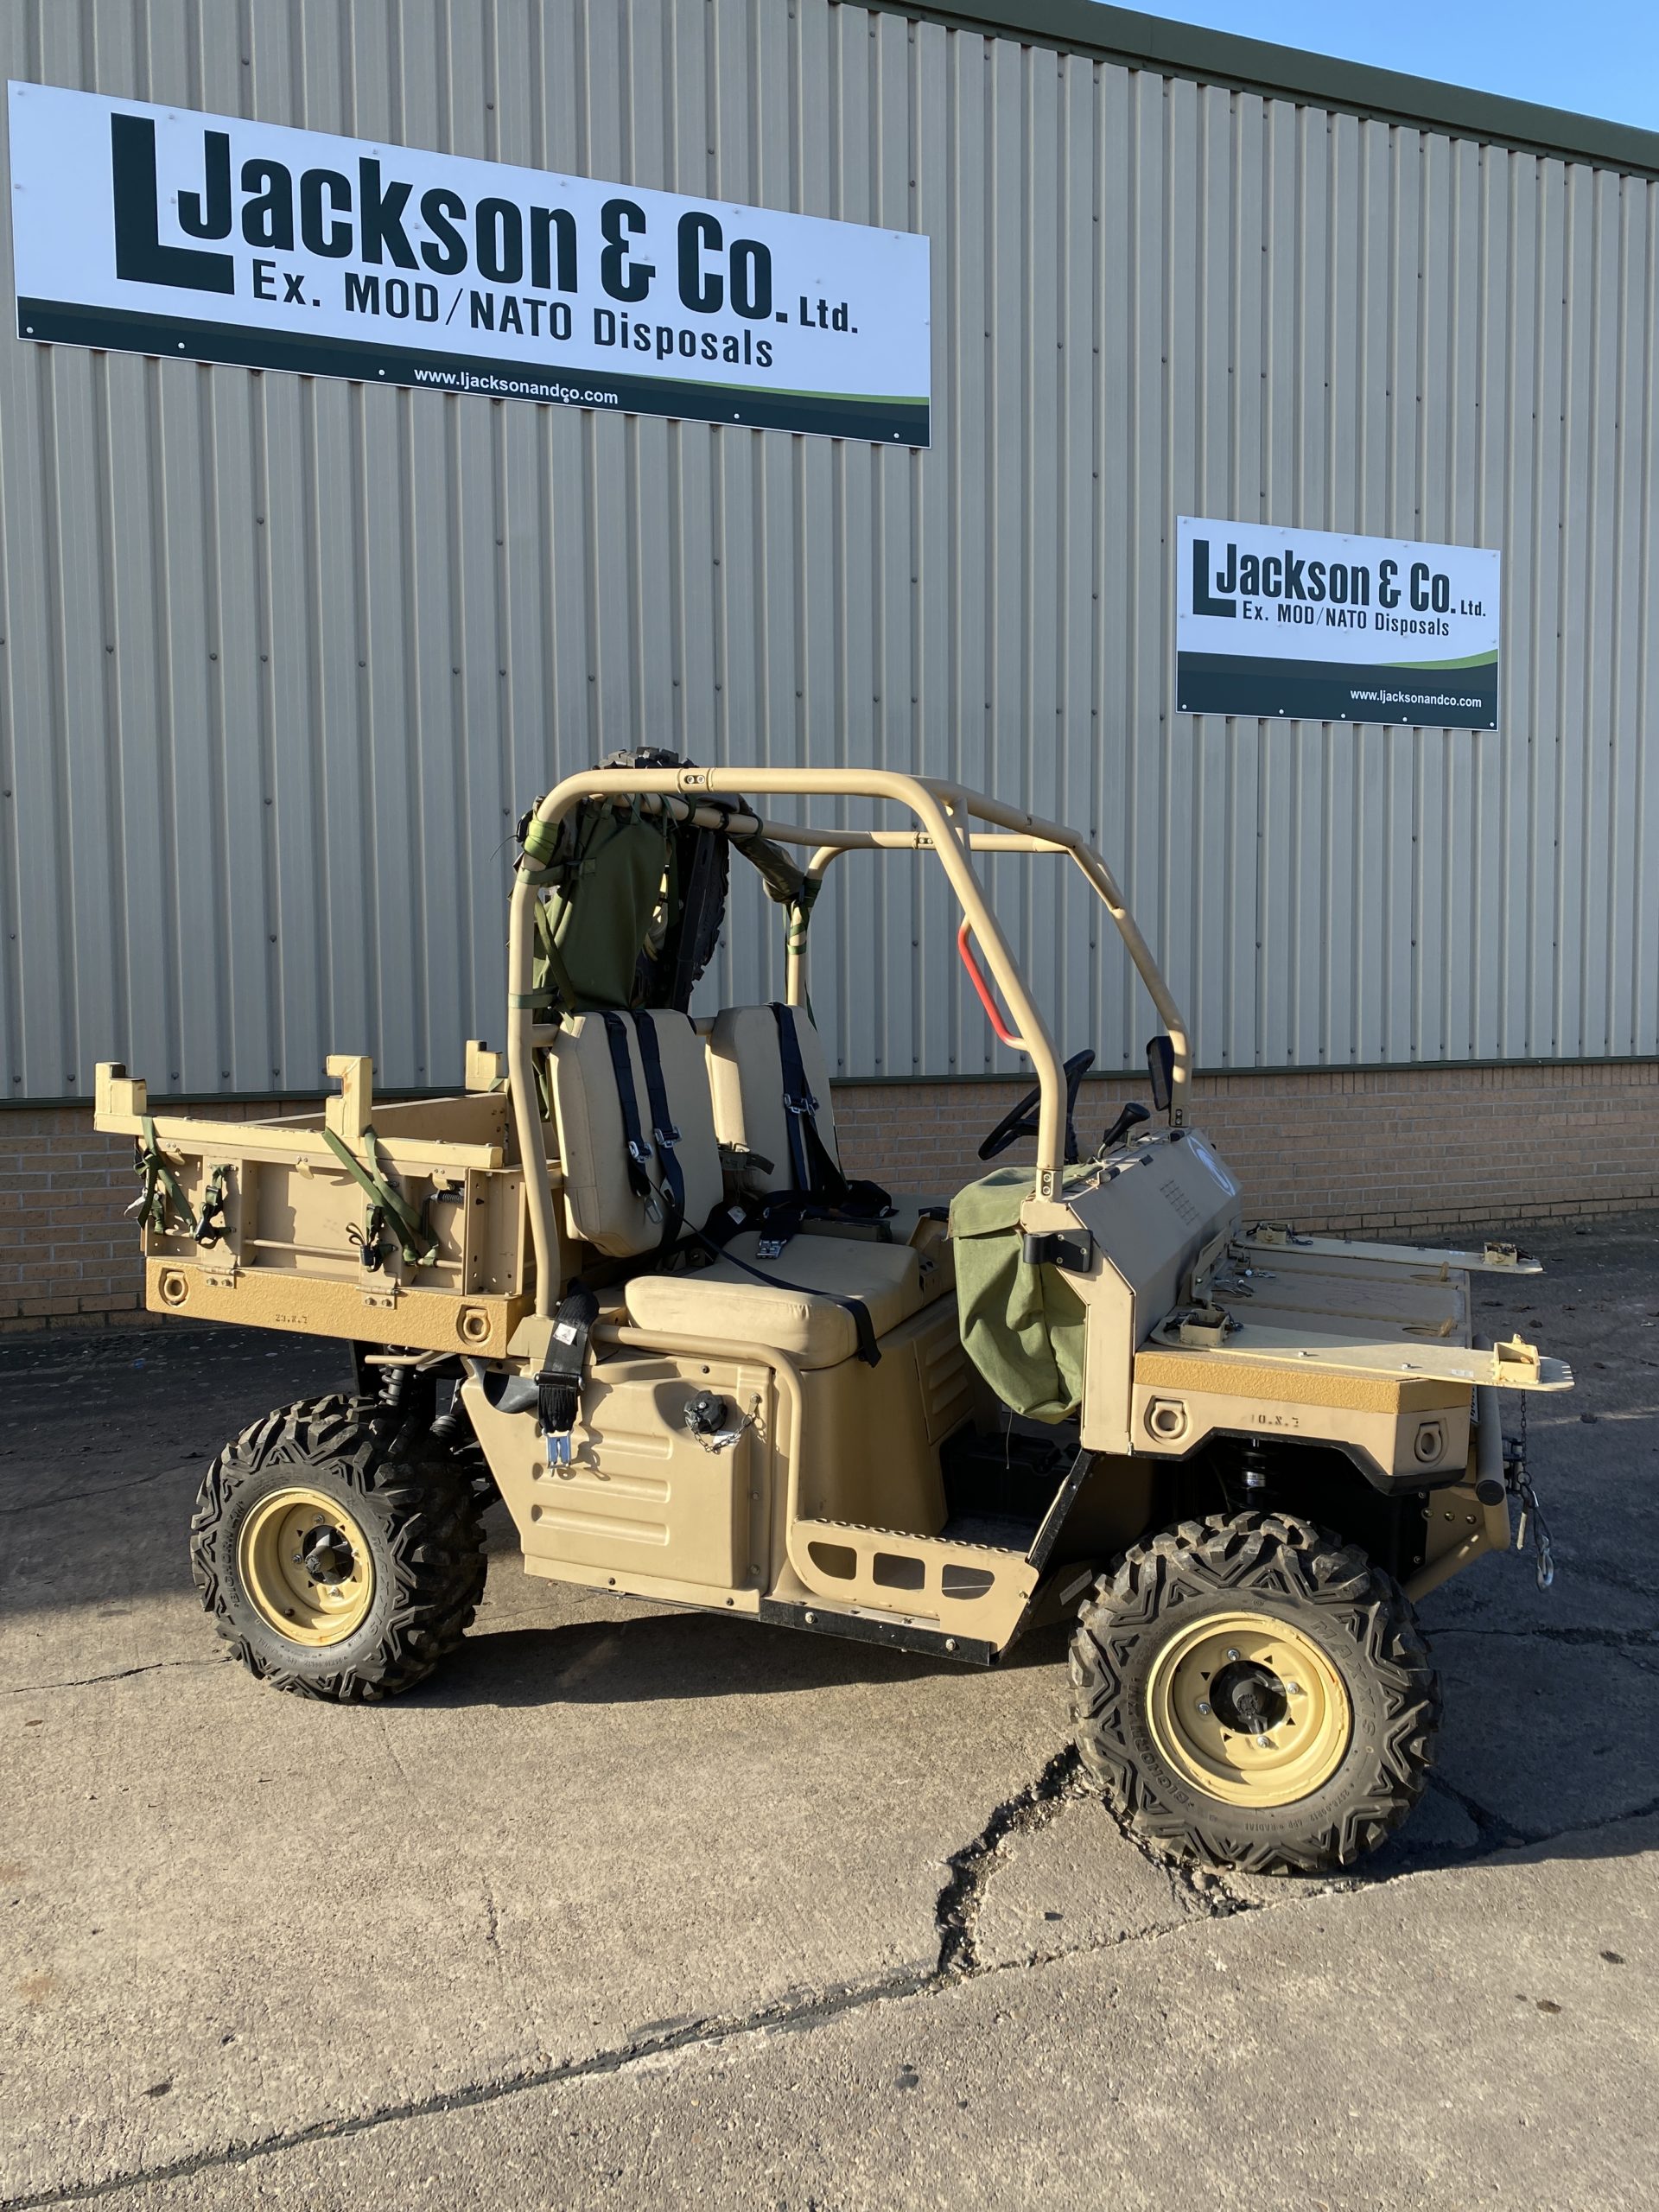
[1128,0,1659,130]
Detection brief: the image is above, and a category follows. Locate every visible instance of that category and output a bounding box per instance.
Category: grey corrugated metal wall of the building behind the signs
[0,0,1659,1099]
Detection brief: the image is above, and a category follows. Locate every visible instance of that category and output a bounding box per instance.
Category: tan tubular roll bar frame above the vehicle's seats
[506,767,1192,1316]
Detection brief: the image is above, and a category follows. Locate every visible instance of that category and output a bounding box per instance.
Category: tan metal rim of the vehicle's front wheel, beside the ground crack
[1146,1612,1354,1808]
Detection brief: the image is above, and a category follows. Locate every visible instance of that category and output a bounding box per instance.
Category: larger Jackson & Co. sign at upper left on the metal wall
[9,84,931,445]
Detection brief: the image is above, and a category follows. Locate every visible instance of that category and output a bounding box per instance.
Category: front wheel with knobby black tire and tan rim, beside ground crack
[1071,1513,1440,1873]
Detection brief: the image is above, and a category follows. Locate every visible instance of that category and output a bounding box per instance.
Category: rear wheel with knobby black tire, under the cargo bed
[190,1395,485,1703]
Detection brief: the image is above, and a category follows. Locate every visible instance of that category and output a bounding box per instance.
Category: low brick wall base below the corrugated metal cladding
[0,1059,1659,1334]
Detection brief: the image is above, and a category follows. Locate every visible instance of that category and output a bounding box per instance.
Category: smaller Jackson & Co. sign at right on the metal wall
[1174,515,1500,730]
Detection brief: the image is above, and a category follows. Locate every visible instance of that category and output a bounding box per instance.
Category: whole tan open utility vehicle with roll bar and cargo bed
[98,754,1573,1869]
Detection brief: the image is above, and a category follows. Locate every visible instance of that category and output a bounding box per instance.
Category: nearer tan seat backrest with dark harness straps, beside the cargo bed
[549,1011,721,1259]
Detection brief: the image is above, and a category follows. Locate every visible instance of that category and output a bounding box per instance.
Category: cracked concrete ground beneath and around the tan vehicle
[0,1217,1659,2212]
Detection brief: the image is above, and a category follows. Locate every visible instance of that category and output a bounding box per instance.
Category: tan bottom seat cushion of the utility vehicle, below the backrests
[626,1234,947,1367]
